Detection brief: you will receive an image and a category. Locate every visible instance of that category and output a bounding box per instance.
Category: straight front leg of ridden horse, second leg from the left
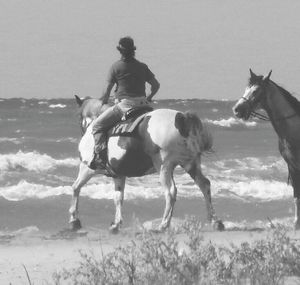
[109,177,126,233]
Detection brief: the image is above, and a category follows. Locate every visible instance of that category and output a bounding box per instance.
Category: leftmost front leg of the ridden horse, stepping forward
[69,162,95,231]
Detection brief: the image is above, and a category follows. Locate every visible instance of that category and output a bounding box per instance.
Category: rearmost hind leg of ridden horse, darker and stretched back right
[187,159,224,230]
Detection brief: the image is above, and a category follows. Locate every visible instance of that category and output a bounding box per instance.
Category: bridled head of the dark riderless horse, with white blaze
[232,69,272,120]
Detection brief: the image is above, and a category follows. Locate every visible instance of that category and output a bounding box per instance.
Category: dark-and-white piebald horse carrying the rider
[69,96,224,232]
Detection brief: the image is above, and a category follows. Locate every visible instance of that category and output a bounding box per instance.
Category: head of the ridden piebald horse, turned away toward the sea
[75,95,107,134]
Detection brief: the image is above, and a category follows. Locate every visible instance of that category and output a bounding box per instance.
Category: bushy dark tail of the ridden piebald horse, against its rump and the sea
[175,111,213,154]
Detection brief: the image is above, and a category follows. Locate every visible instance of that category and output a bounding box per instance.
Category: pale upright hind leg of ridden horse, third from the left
[159,163,177,230]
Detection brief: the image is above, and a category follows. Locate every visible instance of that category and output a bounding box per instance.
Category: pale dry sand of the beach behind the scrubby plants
[0,216,300,284]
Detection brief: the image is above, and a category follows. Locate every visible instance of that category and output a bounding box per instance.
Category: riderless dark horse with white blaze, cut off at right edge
[233,69,300,229]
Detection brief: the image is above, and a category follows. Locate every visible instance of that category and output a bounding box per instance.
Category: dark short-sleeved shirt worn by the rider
[108,58,154,99]
